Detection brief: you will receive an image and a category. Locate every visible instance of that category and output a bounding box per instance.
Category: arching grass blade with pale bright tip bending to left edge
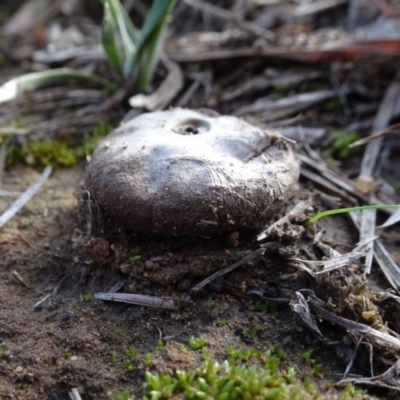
[0,68,116,104]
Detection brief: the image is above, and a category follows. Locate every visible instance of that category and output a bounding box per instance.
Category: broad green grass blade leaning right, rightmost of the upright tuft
[125,0,176,85]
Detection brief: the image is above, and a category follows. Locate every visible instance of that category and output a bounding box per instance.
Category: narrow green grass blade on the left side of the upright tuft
[101,2,123,76]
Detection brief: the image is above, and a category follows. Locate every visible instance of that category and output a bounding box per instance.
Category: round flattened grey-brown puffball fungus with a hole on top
[86,109,299,236]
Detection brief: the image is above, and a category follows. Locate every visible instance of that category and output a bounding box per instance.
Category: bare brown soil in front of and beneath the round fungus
[0,162,394,400]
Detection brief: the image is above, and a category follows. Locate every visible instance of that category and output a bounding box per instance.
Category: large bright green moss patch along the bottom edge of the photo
[144,347,316,400]
